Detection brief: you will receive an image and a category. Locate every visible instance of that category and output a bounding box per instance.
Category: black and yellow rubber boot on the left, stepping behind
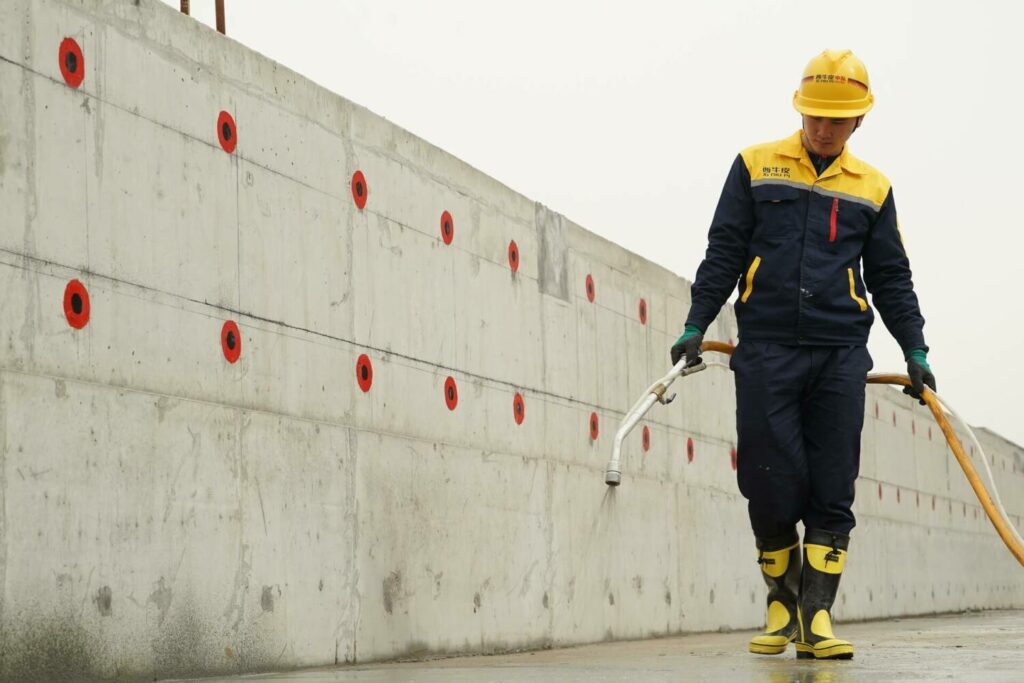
[750,530,800,654]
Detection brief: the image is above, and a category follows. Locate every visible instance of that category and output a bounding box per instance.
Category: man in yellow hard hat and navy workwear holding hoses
[671,50,935,659]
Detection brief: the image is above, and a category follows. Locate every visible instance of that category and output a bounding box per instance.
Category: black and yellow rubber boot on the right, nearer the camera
[797,529,853,659]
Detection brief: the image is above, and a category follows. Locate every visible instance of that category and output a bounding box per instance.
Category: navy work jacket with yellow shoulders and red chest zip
[686,131,928,355]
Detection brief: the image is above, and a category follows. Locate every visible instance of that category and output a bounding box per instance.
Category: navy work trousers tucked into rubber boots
[729,339,872,539]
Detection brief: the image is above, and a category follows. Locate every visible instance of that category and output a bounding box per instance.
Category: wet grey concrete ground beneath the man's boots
[174,610,1024,683]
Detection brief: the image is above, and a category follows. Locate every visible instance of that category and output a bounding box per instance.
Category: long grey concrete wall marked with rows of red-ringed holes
[0,0,1024,681]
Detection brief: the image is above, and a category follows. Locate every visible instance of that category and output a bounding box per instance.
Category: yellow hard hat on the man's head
[793,50,874,119]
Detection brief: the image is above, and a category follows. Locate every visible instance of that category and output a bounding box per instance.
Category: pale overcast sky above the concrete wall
[164,0,1024,450]
